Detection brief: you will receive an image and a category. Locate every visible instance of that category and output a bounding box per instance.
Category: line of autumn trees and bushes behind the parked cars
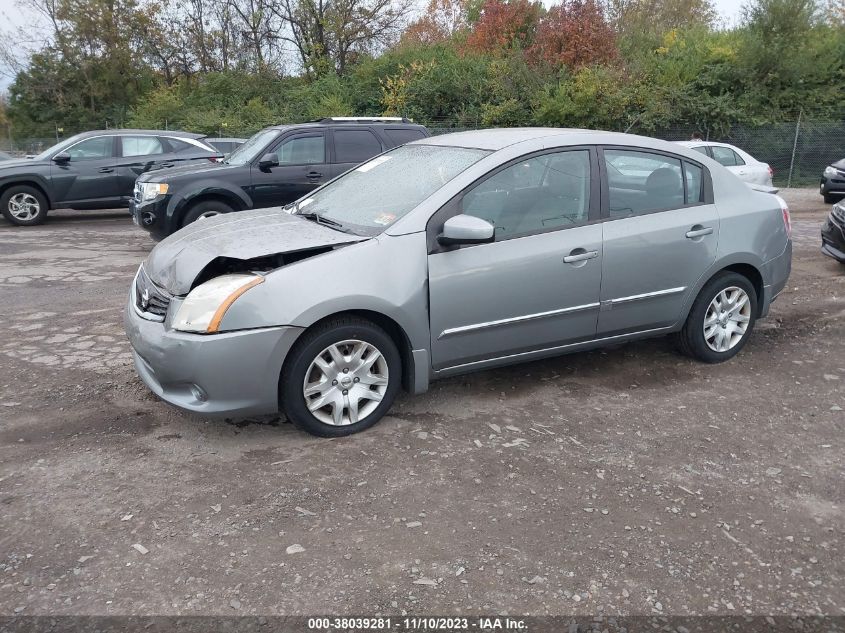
[0,0,845,138]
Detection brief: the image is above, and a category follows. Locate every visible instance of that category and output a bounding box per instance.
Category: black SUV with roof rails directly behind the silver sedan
[131,117,429,239]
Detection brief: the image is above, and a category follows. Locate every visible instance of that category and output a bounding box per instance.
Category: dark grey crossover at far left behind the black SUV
[0,130,222,226]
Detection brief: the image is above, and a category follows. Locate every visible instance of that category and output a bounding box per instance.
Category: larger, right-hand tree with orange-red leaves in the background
[528,0,619,69]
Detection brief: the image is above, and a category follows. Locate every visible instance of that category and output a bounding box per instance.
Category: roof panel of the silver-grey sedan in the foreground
[413,127,684,151]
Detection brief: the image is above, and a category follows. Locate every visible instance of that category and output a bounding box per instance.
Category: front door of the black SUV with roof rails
[250,131,333,209]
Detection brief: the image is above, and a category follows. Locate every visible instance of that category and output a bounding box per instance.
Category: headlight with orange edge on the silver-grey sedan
[172,275,264,334]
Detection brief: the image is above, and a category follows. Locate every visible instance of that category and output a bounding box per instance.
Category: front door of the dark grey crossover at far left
[50,136,121,209]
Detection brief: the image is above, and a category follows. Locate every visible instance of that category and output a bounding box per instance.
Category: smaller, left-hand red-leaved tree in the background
[466,0,541,55]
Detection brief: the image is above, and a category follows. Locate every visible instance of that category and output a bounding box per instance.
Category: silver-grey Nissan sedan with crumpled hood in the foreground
[125,129,792,436]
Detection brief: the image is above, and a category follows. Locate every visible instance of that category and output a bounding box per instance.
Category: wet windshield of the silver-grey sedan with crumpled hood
[297,145,489,235]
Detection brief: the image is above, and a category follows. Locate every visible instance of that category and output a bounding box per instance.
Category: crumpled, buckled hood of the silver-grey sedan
[144,207,369,295]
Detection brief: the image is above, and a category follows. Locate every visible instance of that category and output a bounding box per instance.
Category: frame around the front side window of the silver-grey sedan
[426,145,603,255]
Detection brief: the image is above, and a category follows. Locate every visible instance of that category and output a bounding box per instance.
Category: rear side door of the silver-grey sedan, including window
[598,149,719,338]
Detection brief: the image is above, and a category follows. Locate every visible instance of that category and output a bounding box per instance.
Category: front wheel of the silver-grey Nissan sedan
[279,317,402,437]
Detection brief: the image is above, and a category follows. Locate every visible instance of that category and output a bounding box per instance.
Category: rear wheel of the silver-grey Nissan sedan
[677,271,757,363]
